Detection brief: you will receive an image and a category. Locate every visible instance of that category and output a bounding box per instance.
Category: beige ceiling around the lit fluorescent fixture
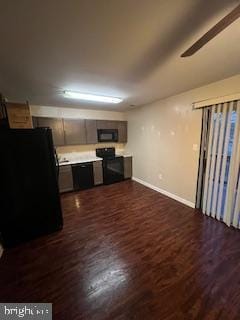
[0,0,240,111]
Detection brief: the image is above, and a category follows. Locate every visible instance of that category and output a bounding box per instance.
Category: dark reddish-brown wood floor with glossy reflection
[0,181,240,320]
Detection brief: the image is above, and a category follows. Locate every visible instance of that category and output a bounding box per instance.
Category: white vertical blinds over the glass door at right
[200,100,240,228]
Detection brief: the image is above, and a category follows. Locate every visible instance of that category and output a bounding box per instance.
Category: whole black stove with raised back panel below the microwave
[96,148,124,184]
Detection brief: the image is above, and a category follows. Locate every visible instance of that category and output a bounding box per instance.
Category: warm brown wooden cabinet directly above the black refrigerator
[6,102,33,129]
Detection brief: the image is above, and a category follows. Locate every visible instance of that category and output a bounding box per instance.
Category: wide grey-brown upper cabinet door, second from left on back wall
[63,119,87,145]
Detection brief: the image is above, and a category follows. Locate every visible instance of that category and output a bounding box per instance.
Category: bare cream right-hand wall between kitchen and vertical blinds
[126,75,240,205]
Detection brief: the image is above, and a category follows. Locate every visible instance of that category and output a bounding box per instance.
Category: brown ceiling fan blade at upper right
[181,5,240,57]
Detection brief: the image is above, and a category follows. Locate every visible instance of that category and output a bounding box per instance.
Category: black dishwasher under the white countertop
[72,162,94,190]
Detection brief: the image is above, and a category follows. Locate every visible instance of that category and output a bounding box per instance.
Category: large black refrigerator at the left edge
[0,128,63,247]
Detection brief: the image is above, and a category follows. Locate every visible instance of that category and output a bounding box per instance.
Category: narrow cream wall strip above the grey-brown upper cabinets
[30,106,125,120]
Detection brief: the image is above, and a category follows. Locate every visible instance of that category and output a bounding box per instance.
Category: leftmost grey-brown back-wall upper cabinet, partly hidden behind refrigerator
[33,117,65,147]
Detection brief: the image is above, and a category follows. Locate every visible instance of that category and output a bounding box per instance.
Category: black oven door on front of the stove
[103,157,124,184]
